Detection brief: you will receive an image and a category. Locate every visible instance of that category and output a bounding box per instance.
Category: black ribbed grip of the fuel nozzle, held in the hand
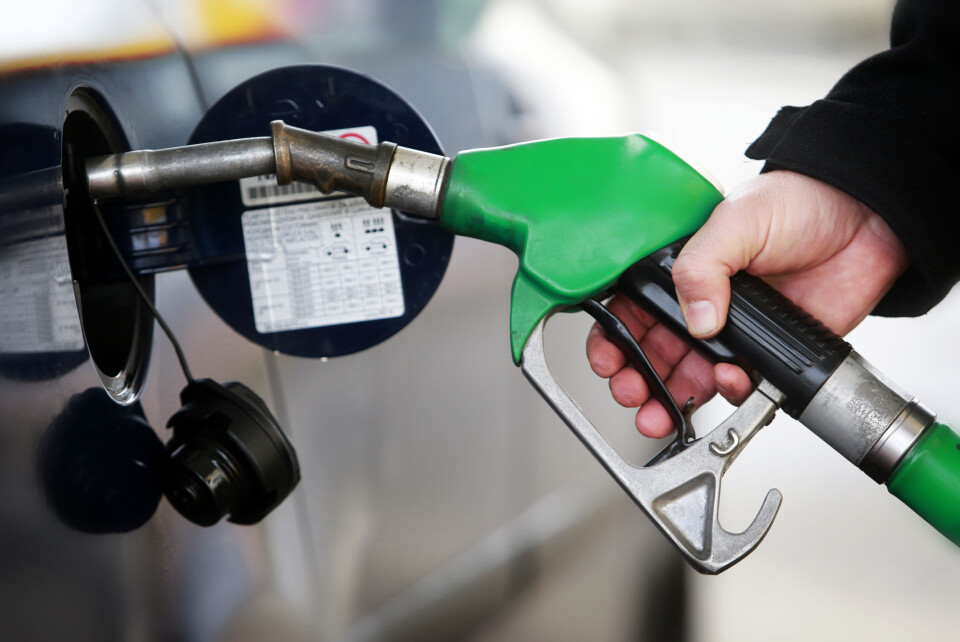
[618,241,852,418]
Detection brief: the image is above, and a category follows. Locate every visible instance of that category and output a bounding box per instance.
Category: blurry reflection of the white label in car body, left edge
[0,236,84,354]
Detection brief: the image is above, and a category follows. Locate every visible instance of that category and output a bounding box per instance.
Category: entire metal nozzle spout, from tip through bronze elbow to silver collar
[86,120,451,219]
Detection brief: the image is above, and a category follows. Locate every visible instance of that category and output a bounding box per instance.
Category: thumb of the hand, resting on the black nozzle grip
[673,198,769,339]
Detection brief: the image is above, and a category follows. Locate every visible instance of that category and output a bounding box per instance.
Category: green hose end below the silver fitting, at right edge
[887,422,960,545]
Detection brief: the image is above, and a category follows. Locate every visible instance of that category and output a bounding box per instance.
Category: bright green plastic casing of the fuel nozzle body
[441,134,723,363]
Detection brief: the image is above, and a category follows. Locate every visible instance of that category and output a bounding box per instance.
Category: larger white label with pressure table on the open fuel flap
[241,197,404,333]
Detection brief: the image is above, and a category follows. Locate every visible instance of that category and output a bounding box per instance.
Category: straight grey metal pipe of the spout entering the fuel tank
[86,136,277,198]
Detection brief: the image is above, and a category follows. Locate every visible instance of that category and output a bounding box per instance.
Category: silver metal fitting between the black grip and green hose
[799,352,934,483]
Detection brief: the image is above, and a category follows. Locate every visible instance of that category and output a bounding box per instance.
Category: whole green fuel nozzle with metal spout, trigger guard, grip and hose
[87,122,960,573]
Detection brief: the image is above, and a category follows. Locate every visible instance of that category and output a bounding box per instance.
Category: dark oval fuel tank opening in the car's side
[62,87,154,404]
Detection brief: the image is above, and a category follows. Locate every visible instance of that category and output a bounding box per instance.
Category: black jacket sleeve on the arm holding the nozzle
[747,0,960,316]
